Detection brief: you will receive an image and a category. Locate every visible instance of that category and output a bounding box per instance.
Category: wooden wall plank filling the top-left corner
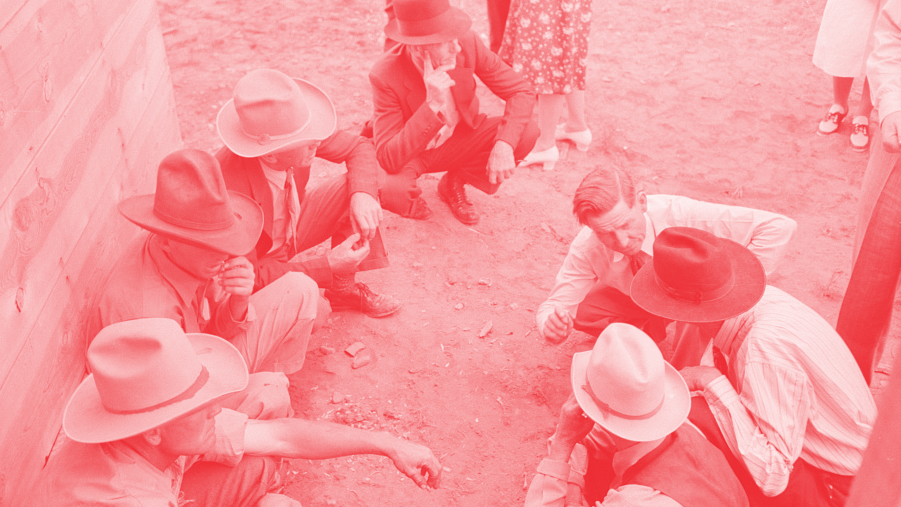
[0,0,134,198]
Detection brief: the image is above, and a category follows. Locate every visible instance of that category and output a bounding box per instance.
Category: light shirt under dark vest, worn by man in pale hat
[525,438,681,507]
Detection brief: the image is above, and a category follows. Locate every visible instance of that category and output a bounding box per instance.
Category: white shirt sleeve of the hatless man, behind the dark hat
[657,197,798,275]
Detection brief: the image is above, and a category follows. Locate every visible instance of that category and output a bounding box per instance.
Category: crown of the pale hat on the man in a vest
[586,323,666,418]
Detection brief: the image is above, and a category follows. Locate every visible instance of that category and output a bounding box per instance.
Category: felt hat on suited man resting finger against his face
[385,0,472,44]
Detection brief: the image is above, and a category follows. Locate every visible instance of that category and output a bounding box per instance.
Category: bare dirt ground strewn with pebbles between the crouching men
[160,0,884,507]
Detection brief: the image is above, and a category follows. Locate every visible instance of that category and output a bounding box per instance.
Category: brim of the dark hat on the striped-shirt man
[630,238,766,322]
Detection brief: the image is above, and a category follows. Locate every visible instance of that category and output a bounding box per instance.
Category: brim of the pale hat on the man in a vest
[571,350,691,442]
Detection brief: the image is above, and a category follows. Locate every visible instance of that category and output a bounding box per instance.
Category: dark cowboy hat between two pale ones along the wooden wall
[119,149,263,255]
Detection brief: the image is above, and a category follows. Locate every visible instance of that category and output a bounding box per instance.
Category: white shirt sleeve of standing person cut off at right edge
[867,0,901,122]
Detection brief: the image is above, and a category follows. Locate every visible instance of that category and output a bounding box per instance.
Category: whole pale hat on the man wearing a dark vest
[571,323,691,442]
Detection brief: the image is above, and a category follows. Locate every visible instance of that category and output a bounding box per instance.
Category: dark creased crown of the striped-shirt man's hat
[653,227,735,302]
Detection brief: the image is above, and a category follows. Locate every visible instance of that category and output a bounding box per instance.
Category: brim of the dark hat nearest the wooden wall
[119,190,263,256]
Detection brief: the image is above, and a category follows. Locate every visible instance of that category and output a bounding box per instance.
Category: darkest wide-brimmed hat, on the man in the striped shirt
[631,227,766,322]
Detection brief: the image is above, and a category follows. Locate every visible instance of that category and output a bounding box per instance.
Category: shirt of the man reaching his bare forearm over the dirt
[37,409,247,507]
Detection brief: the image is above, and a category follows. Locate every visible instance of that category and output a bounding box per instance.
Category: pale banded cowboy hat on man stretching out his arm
[63,318,248,444]
